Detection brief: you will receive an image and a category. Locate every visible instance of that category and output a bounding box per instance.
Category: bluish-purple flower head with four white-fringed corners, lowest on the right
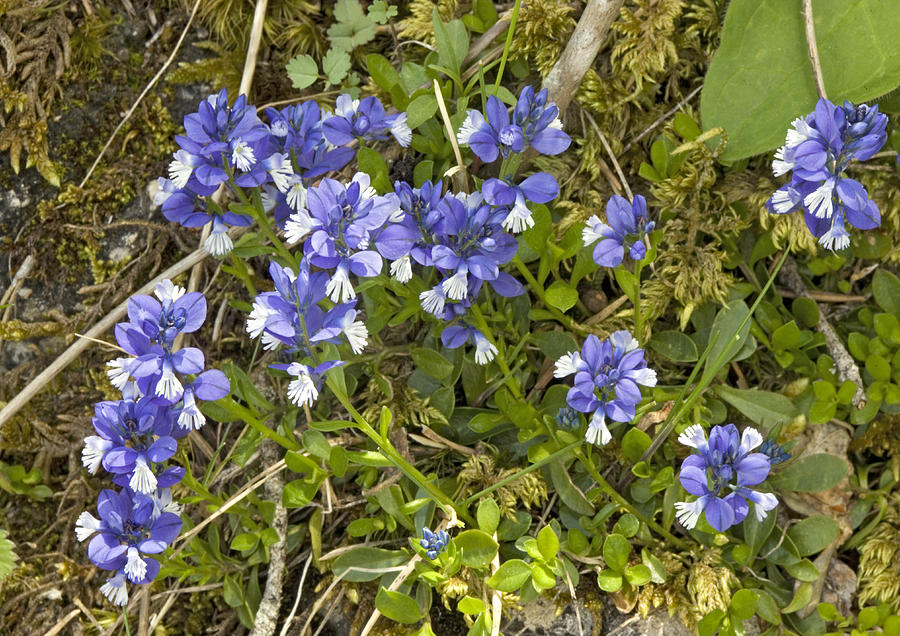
[675,424,778,532]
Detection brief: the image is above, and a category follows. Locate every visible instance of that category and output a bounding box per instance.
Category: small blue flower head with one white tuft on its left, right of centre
[582,194,655,267]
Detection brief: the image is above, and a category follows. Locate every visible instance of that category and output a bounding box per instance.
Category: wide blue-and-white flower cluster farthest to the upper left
[155,90,412,256]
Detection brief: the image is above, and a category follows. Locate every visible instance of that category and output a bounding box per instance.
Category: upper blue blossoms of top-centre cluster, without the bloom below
[456,86,571,163]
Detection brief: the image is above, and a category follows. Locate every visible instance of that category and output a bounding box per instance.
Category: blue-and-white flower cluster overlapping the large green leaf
[766,98,887,250]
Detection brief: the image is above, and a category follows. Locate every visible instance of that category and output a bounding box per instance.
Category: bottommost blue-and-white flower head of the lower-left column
[75,490,181,605]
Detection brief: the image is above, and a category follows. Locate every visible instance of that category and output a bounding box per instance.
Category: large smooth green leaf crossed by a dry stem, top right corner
[700,0,900,161]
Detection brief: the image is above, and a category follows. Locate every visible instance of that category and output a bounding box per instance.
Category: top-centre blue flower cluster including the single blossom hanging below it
[456,86,572,233]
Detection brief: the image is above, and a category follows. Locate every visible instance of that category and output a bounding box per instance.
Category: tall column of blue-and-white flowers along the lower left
[75,280,230,605]
